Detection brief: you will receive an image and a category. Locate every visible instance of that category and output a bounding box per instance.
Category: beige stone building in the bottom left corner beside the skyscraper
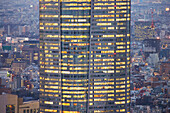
[0,94,39,113]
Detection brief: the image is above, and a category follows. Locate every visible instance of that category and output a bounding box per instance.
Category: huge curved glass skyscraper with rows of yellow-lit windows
[40,0,130,113]
